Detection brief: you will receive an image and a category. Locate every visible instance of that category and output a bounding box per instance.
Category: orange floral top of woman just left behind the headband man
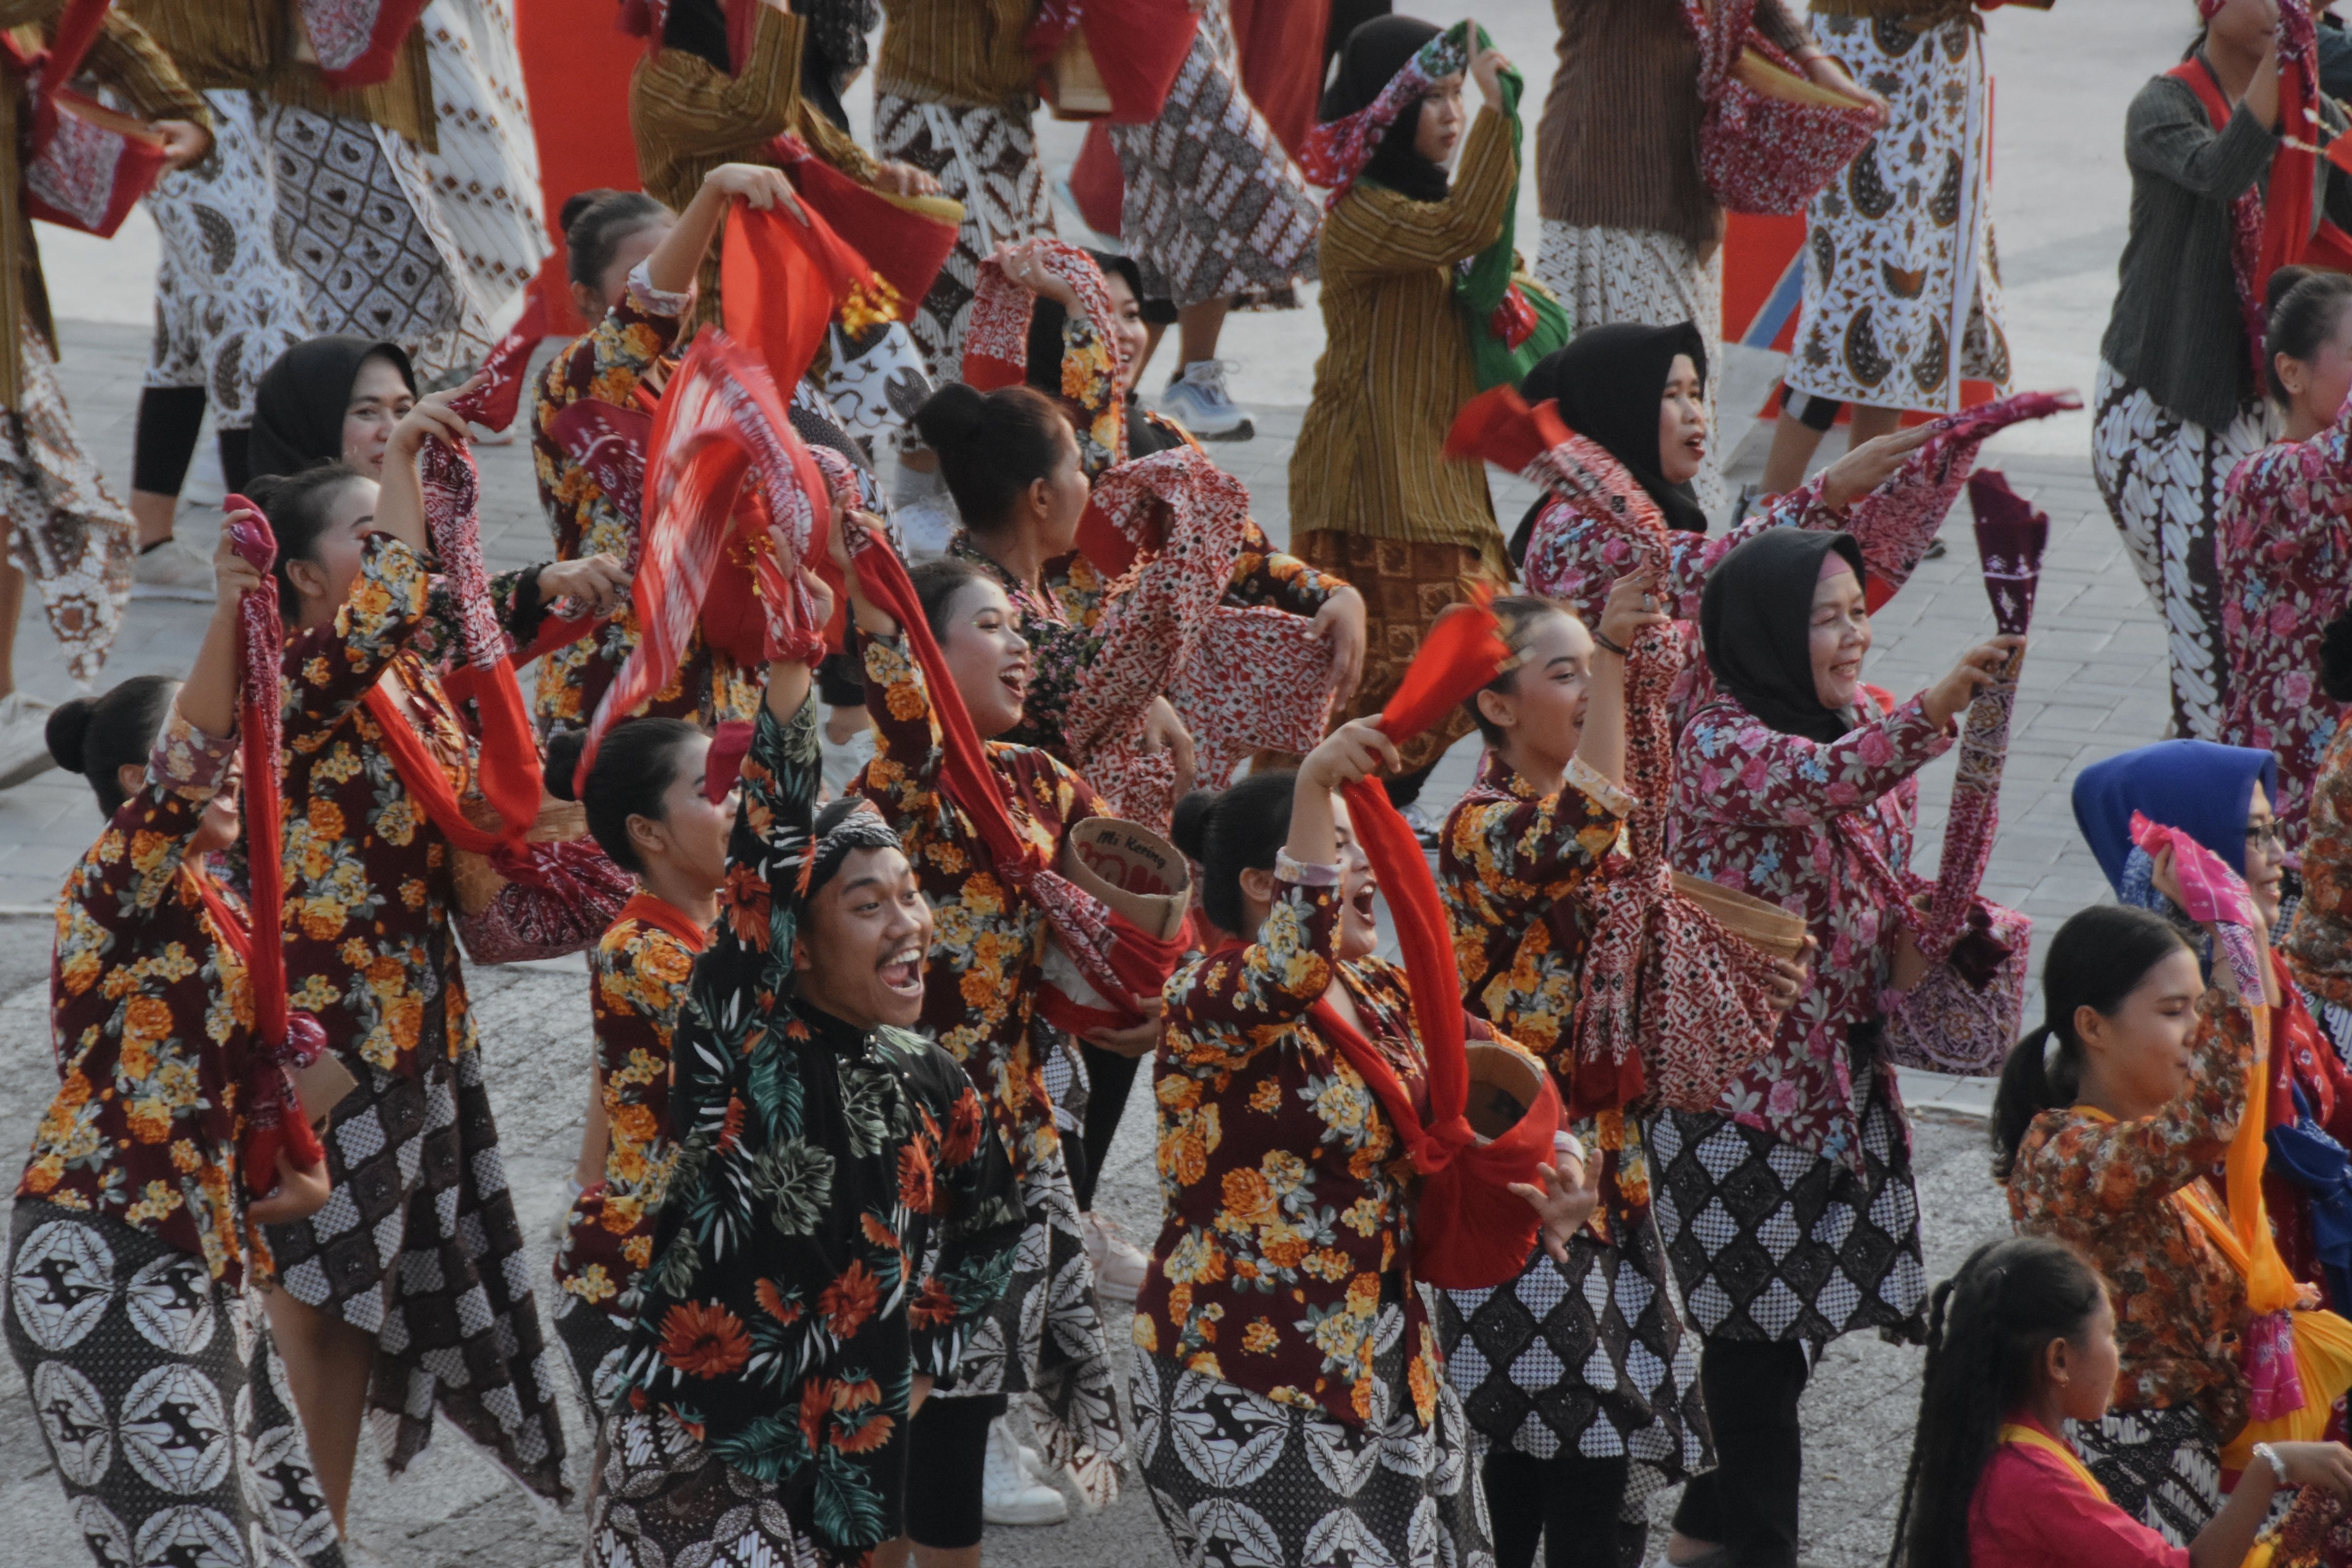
[555,912,701,1328]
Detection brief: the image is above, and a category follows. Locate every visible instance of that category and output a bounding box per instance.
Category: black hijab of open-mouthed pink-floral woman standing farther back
[1510,322,1707,564]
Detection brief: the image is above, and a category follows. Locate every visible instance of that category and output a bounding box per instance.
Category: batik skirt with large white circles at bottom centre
[1127,1344,1494,1568]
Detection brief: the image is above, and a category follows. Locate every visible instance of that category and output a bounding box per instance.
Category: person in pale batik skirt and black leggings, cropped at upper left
[120,0,308,600]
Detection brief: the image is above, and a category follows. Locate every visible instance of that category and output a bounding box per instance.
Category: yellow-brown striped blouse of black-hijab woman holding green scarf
[1291,108,1519,581]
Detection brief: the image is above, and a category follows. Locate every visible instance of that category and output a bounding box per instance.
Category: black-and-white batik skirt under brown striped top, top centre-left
[875,92,1054,381]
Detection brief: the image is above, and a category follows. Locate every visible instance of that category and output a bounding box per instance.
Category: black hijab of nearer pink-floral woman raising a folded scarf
[1698,529,1870,743]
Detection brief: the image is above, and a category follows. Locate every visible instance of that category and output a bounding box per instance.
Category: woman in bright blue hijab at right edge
[2074,740,2352,1309]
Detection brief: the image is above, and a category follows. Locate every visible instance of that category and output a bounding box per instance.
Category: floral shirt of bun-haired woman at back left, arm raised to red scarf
[532,263,765,731]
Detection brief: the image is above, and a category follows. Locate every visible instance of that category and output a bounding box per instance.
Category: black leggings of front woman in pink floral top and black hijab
[1675,1340,1811,1568]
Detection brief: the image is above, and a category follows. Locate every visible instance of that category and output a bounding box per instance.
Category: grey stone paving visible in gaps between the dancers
[0,322,2164,1568]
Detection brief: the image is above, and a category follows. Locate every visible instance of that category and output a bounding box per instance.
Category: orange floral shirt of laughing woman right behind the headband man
[858,637,1110,1175]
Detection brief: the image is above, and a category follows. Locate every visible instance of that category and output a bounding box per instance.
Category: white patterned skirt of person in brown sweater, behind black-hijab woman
[1536,218,1724,517]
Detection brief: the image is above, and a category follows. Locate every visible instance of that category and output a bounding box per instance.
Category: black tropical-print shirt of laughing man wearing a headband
[621,696,1021,1563]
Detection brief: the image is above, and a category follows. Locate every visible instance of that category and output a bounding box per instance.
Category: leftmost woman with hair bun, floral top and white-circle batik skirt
[7,529,343,1568]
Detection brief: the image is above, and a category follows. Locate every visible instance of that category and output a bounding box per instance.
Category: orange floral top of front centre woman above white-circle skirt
[1134,856,1494,1427]
